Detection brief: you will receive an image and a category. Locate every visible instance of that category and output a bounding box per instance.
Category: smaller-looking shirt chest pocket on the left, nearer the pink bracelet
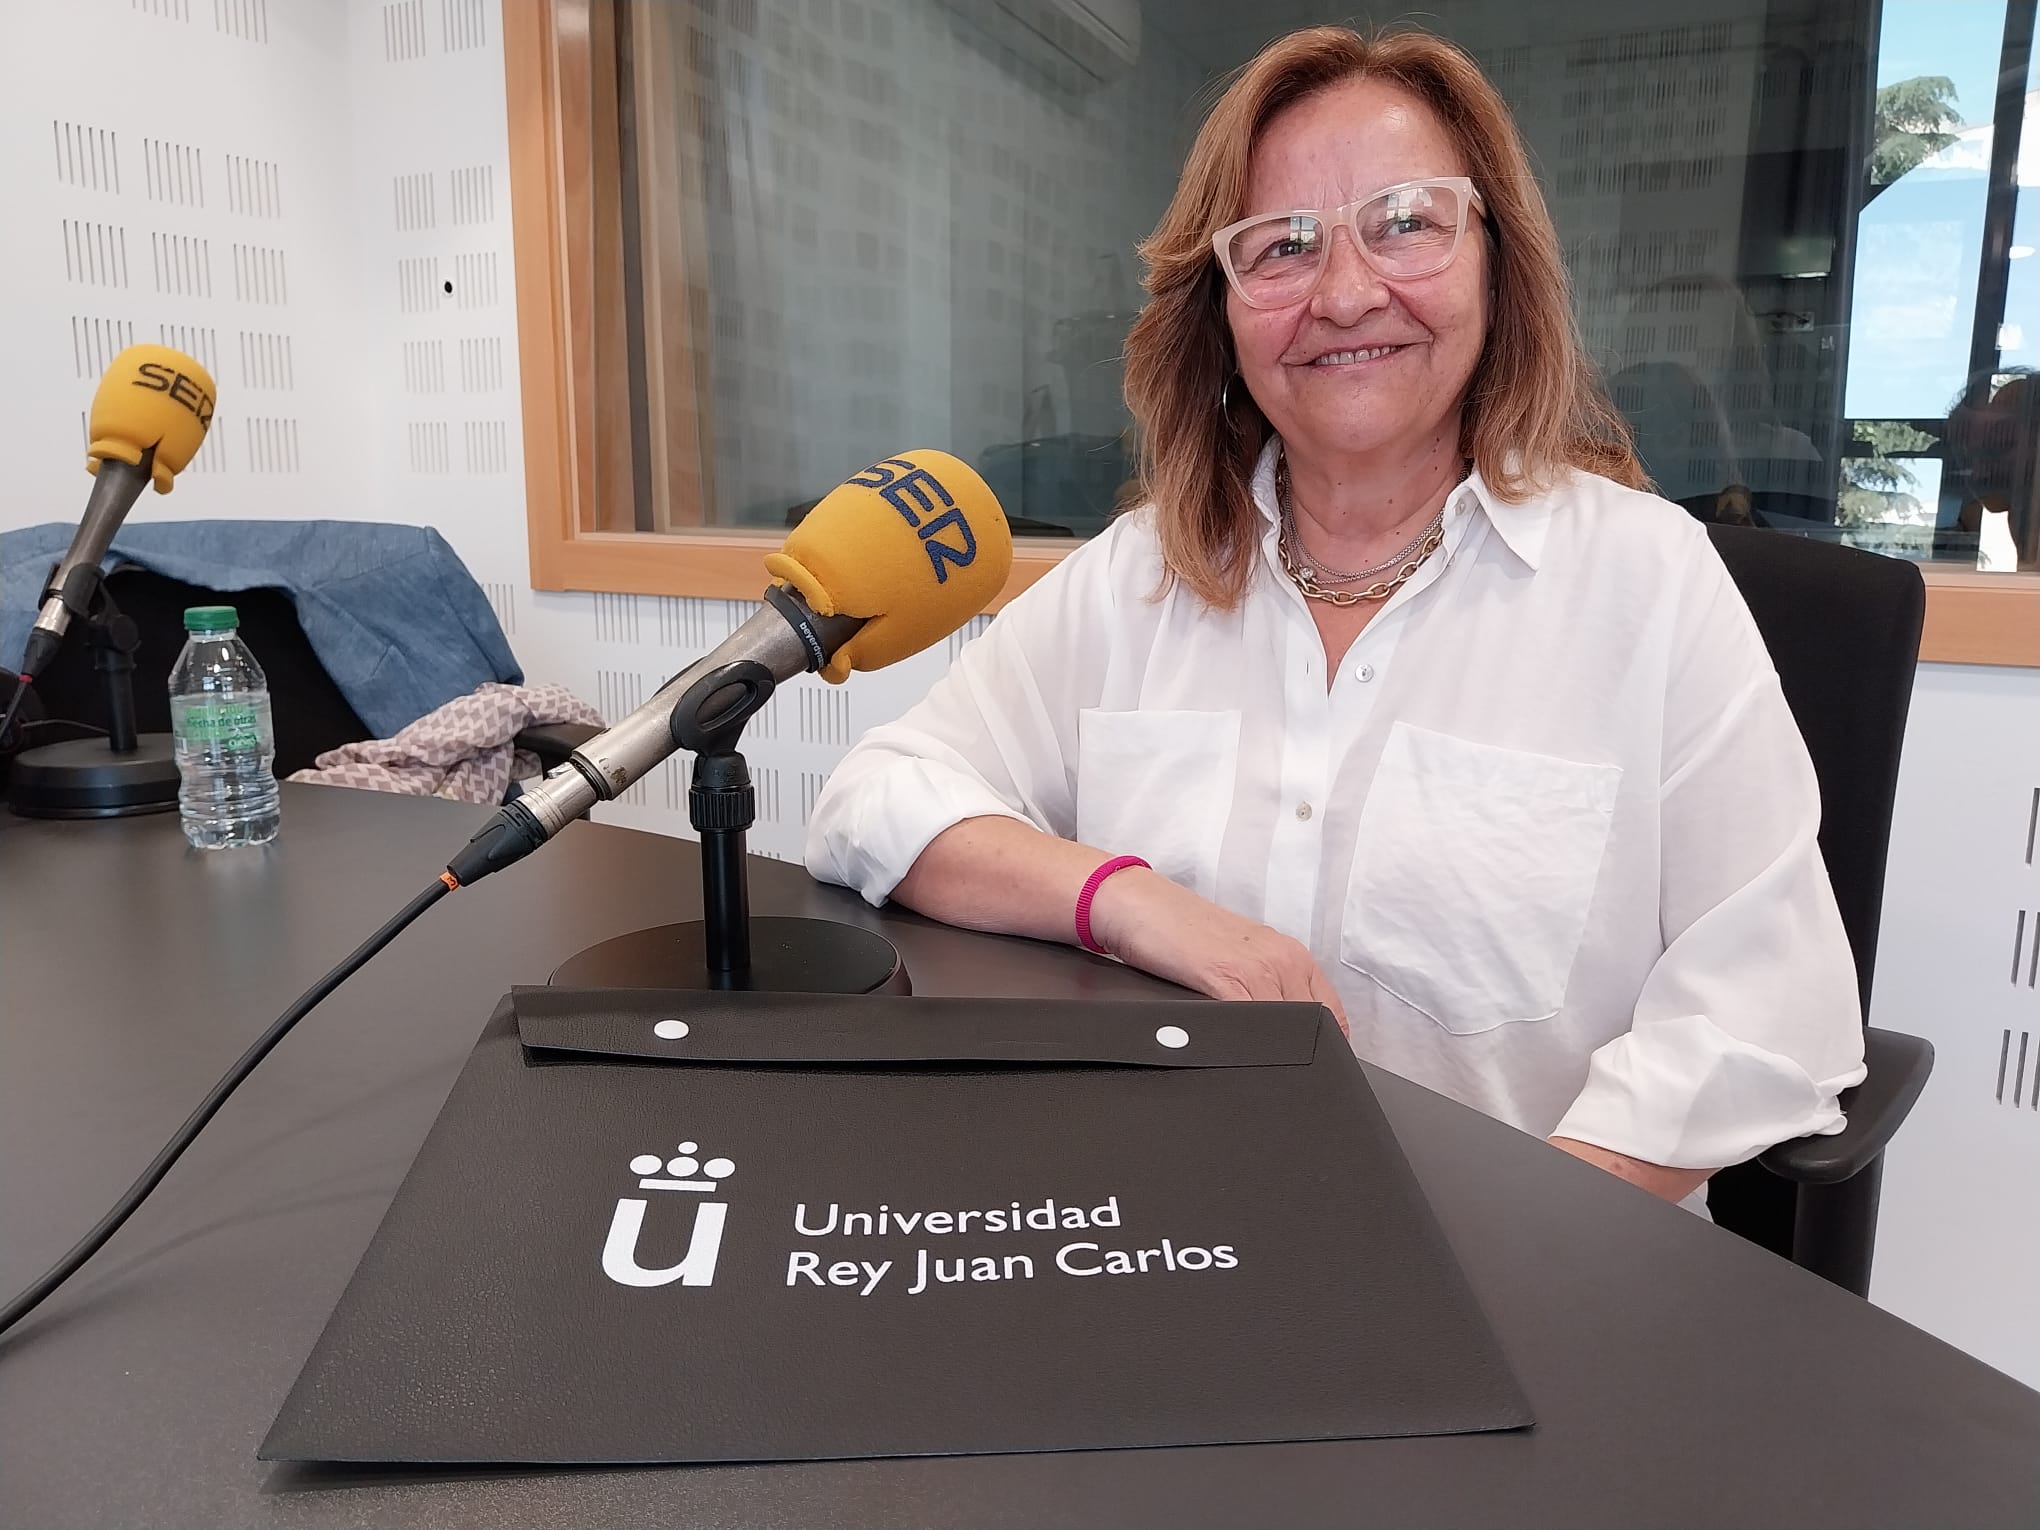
[1077,708,1240,898]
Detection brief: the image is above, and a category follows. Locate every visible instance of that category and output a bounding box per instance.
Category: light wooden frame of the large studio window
[502,0,2040,667]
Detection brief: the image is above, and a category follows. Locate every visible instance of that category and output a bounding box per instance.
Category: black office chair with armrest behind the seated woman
[1707,526,1934,1295]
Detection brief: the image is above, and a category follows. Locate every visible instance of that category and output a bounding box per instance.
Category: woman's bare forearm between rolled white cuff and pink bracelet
[891,818,1106,940]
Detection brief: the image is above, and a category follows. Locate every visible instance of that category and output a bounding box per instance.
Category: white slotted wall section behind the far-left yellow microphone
[0,0,373,526]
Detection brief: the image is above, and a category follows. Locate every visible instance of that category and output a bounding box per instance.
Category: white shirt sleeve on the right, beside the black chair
[1554,526,1863,1169]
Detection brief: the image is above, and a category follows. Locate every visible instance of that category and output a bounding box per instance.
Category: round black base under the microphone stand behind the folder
[551,918,914,996]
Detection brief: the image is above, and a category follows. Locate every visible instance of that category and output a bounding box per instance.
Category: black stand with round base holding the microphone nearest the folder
[553,659,914,993]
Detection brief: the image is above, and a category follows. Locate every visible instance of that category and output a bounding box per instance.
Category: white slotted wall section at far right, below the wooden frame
[1871,665,2040,1387]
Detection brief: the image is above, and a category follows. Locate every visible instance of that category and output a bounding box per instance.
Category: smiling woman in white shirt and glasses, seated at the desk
[808,29,1863,1200]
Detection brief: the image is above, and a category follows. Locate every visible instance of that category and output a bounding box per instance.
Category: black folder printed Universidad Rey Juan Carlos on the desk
[261,989,1532,1465]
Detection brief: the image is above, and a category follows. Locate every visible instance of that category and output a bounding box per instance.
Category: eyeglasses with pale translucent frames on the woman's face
[1212,175,1485,308]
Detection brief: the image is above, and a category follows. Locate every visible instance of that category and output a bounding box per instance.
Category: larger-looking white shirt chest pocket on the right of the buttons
[1338,722,1622,1034]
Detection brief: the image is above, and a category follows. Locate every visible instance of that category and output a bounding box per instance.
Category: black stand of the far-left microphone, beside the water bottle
[6,563,177,818]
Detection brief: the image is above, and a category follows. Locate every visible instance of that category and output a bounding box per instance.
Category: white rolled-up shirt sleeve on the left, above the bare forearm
[806,532,1114,904]
